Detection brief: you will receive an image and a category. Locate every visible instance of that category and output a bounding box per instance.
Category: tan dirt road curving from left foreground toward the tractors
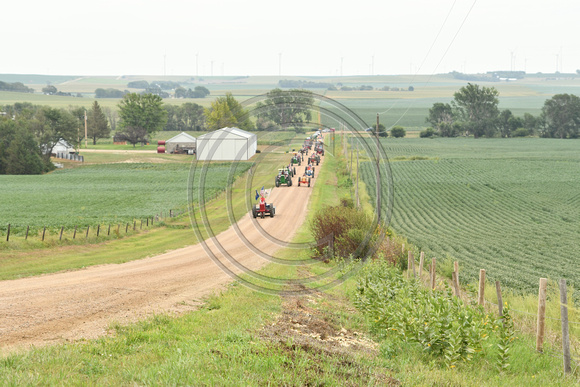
[0,154,324,353]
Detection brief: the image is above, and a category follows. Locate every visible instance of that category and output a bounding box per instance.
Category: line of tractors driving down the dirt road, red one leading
[252,135,324,218]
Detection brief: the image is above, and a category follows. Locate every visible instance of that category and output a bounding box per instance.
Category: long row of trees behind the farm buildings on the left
[0,89,314,174]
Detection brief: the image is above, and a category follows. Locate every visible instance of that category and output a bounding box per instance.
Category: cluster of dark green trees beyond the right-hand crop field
[421,83,580,139]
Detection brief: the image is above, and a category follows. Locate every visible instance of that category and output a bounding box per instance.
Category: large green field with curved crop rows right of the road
[361,138,580,292]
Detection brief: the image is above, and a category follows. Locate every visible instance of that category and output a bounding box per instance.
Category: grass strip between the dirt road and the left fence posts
[0,148,296,280]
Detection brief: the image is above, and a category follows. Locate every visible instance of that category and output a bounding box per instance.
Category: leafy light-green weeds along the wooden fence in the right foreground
[354,261,513,369]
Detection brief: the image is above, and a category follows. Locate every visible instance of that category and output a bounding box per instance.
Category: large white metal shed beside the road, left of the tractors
[197,128,258,161]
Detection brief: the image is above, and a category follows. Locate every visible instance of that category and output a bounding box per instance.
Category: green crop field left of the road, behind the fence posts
[0,163,250,235]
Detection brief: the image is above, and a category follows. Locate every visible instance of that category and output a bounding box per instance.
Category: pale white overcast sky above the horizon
[0,0,580,76]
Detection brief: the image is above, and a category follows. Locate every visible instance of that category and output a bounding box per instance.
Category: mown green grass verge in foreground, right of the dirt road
[0,138,577,386]
